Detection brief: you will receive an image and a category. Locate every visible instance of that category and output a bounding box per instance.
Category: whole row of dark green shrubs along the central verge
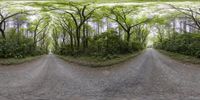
[53,29,146,59]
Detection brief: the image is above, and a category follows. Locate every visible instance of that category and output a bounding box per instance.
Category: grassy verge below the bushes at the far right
[159,50,200,64]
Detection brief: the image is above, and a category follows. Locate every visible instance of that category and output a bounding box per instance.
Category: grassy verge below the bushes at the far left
[0,56,41,65]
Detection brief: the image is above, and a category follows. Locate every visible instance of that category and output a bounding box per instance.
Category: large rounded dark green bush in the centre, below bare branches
[91,30,128,56]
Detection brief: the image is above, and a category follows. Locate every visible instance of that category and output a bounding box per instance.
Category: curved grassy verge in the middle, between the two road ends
[58,51,142,67]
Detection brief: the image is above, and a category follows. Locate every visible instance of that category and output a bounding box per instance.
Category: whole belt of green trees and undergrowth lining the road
[0,0,200,66]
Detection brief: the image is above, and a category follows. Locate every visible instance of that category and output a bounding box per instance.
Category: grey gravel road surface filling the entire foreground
[0,49,200,100]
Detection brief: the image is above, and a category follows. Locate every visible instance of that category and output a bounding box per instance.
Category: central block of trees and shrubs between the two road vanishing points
[52,2,151,59]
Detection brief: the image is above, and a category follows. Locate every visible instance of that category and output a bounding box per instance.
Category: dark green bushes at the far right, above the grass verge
[155,33,200,58]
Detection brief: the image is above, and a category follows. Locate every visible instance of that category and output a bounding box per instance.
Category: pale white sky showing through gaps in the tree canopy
[2,1,200,44]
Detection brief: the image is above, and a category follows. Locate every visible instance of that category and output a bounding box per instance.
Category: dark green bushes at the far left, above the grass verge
[0,29,46,58]
